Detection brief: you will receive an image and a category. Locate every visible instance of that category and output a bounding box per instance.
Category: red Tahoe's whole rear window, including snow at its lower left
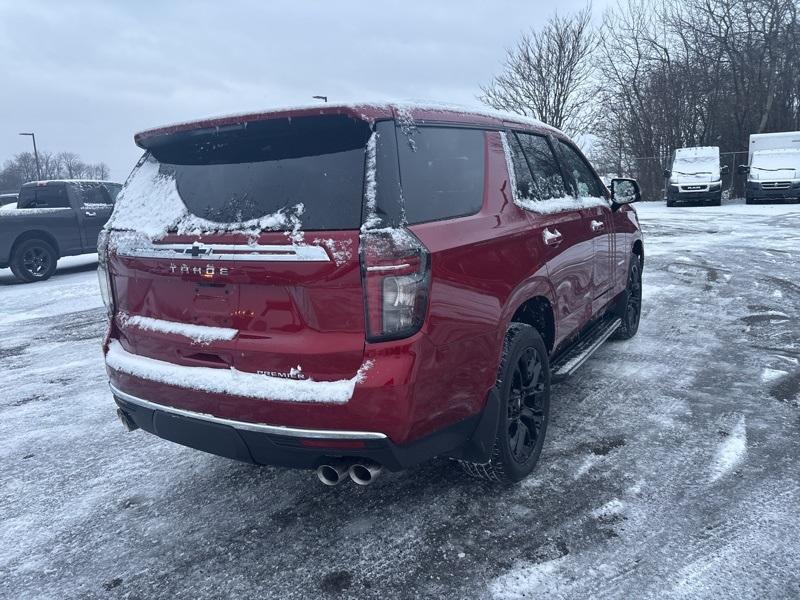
[108,116,371,241]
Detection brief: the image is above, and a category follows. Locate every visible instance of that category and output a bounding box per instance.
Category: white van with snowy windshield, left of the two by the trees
[664,146,728,206]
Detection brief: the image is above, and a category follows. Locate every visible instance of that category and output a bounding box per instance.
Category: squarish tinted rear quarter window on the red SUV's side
[397,127,486,224]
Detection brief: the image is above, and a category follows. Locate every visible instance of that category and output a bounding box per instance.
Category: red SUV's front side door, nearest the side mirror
[557,140,614,315]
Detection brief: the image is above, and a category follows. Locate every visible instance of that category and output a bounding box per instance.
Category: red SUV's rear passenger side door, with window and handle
[509,132,594,344]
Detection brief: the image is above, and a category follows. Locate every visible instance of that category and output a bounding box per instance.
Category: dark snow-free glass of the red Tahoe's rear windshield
[145,115,370,230]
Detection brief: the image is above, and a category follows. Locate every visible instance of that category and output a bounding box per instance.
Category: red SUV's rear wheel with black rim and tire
[461,323,550,483]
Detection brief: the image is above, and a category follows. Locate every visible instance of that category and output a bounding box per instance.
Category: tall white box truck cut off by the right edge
[739,131,800,204]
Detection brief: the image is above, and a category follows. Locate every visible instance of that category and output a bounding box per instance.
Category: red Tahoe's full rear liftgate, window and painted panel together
[110,116,374,380]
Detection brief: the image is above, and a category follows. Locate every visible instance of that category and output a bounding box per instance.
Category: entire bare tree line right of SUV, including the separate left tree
[481,0,800,198]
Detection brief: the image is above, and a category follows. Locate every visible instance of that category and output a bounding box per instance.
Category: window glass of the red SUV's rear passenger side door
[509,133,569,200]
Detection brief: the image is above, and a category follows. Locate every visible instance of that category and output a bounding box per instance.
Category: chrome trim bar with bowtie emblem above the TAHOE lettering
[118,244,331,262]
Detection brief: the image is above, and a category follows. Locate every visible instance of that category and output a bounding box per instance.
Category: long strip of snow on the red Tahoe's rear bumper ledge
[106,340,370,404]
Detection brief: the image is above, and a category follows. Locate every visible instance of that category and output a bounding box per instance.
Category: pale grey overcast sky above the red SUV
[0,0,606,181]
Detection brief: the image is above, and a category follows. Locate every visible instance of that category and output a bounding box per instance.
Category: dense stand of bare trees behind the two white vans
[594,0,800,198]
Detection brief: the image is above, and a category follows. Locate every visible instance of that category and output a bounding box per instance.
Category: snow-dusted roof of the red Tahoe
[134,102,564,148]
